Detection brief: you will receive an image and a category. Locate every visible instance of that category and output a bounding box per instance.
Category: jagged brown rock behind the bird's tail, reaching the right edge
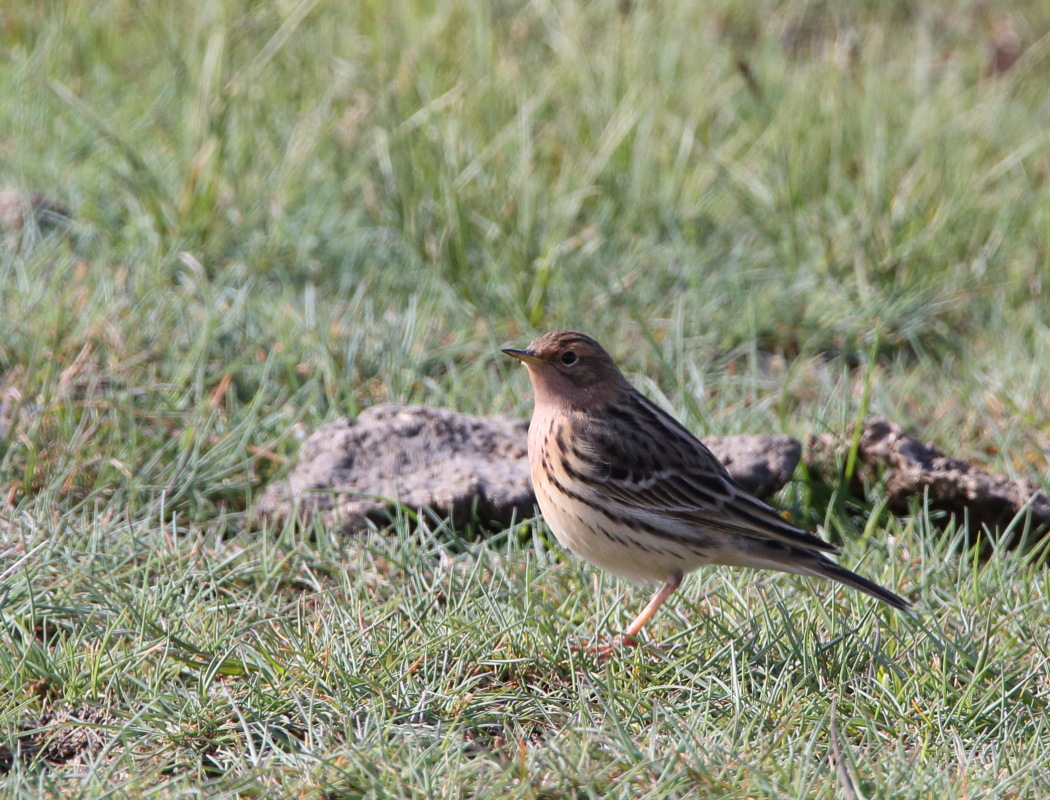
[804,418,1050,534]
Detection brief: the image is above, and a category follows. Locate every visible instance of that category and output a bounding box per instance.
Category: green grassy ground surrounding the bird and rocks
[0,0,1050,798]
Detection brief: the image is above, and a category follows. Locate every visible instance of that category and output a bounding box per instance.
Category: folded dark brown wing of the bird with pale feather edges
[571,393,838,552]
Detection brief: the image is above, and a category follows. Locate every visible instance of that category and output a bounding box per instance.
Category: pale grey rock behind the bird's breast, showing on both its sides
[256,405,801,533]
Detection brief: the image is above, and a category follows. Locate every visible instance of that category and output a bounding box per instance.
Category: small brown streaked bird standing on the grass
[503,331,909,654]
